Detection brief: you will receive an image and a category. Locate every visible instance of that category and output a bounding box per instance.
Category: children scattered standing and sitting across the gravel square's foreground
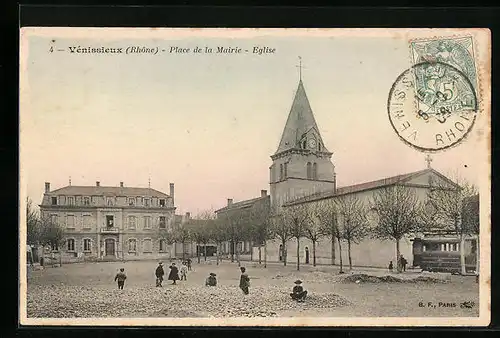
[115,261,308,302]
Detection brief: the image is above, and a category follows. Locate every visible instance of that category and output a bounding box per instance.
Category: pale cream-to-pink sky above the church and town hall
[20,27,484,214]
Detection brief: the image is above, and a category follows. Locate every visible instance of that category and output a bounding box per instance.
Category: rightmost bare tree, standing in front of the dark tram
[428,175,479,274]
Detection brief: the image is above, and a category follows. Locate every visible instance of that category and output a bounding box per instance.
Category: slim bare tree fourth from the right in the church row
[315,199,342,272]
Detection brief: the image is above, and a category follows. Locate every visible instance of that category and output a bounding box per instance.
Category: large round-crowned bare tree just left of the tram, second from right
[371,184,422,272]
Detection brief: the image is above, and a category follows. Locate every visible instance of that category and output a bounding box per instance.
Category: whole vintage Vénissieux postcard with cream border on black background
[19,27,491,326]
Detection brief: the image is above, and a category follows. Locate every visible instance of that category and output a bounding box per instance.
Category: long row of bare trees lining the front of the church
[172,180,479,273]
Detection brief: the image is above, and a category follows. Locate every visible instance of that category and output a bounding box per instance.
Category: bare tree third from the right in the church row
[335,194,369,270]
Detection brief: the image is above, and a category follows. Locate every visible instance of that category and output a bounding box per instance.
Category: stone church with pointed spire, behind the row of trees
[216,74,464,267]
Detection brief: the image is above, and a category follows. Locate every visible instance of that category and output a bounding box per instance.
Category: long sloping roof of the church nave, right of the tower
[285,168,456,205]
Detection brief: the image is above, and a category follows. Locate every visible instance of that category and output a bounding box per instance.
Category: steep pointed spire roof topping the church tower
[276,80,328,154]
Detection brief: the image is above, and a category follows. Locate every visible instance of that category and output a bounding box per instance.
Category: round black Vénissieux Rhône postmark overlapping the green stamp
[387,62,478,152]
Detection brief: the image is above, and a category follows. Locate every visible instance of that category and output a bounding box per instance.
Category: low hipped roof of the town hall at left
[49,185,170,198]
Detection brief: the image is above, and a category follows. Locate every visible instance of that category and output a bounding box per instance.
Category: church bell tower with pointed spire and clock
[269,74,336,211]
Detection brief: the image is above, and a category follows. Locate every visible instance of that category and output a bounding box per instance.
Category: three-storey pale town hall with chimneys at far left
[40,182,175,262]
